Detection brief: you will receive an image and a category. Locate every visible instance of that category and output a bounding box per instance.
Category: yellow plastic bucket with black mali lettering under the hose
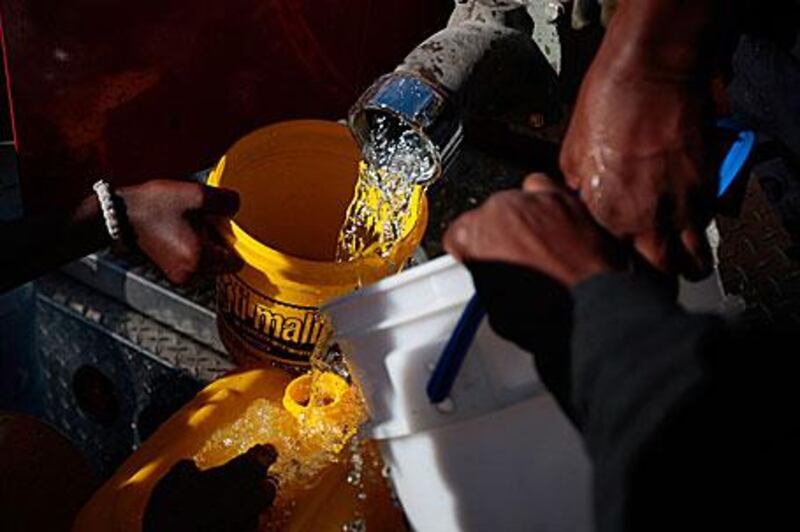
[209,120,428,367]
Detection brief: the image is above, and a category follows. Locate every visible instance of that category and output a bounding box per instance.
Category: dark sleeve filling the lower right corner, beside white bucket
[571,273,798,532]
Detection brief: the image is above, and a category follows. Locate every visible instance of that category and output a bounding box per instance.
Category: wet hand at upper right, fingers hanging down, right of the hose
[561,55,716,278]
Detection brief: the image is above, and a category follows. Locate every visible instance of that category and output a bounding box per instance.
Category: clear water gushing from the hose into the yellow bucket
[336,117,436,262]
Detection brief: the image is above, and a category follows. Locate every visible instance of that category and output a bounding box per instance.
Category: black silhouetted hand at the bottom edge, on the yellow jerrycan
[142,445,277,532]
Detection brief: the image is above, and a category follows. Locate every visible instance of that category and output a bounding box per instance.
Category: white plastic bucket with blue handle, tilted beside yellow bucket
[323,257,591,532]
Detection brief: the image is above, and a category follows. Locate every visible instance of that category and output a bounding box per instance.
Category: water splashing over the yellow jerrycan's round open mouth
[194,337,402,531]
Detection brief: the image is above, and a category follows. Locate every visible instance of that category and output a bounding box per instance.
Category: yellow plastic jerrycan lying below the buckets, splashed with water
[72,368,406,532]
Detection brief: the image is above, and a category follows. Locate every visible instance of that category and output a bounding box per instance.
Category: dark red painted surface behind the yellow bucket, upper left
[0,0,451,210]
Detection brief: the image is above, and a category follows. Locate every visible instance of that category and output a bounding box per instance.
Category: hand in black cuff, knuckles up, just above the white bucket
[444,174,621,287]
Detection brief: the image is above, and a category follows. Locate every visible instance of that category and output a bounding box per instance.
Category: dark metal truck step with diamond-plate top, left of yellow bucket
[37,274,233,476]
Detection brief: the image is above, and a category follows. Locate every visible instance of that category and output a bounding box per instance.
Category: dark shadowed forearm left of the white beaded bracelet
[0,195,110,292]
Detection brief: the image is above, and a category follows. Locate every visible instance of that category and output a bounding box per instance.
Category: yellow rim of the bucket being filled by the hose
[207,119,429,285]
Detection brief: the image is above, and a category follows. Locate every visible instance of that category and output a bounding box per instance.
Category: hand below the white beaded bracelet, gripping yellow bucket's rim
[117,180,242,284]
